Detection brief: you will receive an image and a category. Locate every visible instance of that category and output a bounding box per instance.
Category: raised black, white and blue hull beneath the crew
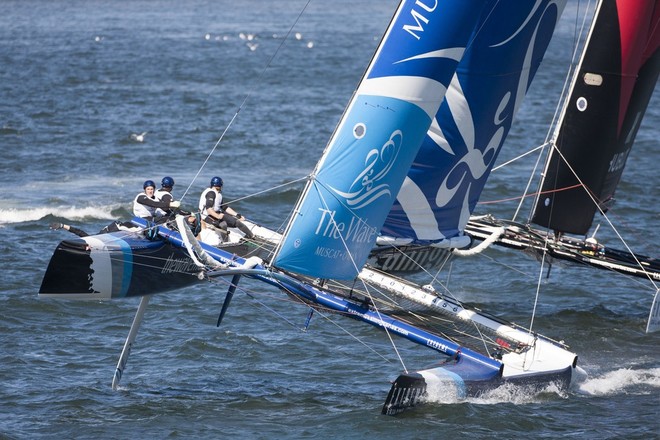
[39,217,258,300]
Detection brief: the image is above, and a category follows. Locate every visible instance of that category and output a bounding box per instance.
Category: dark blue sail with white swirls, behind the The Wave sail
[382,0,566,244]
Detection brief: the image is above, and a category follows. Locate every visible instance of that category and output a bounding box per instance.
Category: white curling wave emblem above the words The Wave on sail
[331,130,403,209]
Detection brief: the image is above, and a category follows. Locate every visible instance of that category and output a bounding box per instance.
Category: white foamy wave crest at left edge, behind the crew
[0,205,124,224]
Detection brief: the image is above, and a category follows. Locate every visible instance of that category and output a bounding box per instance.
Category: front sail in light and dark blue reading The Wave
[274,0,495,279]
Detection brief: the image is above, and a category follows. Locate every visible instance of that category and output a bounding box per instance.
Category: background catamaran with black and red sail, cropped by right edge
[467,0,660,280]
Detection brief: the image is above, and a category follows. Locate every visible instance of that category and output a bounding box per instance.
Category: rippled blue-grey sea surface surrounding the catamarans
[0,0,660,439]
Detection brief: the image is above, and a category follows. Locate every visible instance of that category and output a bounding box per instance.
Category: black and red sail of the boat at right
[532,0,660,234]
